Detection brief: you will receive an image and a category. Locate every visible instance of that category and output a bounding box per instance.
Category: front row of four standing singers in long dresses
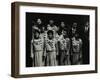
[31,29,82,67]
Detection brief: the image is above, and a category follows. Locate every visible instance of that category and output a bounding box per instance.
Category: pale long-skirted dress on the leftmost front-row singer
[32,38,44,67]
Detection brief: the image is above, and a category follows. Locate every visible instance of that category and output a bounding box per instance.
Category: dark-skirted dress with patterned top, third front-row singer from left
[58,37,70,65]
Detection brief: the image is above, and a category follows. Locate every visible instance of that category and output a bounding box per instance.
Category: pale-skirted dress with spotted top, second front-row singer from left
[45,38,57,66]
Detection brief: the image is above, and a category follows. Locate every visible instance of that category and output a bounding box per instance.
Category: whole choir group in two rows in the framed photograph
[31,18,89,67]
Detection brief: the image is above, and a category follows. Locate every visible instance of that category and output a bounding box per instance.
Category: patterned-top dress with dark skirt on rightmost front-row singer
[72,37,82,64]
